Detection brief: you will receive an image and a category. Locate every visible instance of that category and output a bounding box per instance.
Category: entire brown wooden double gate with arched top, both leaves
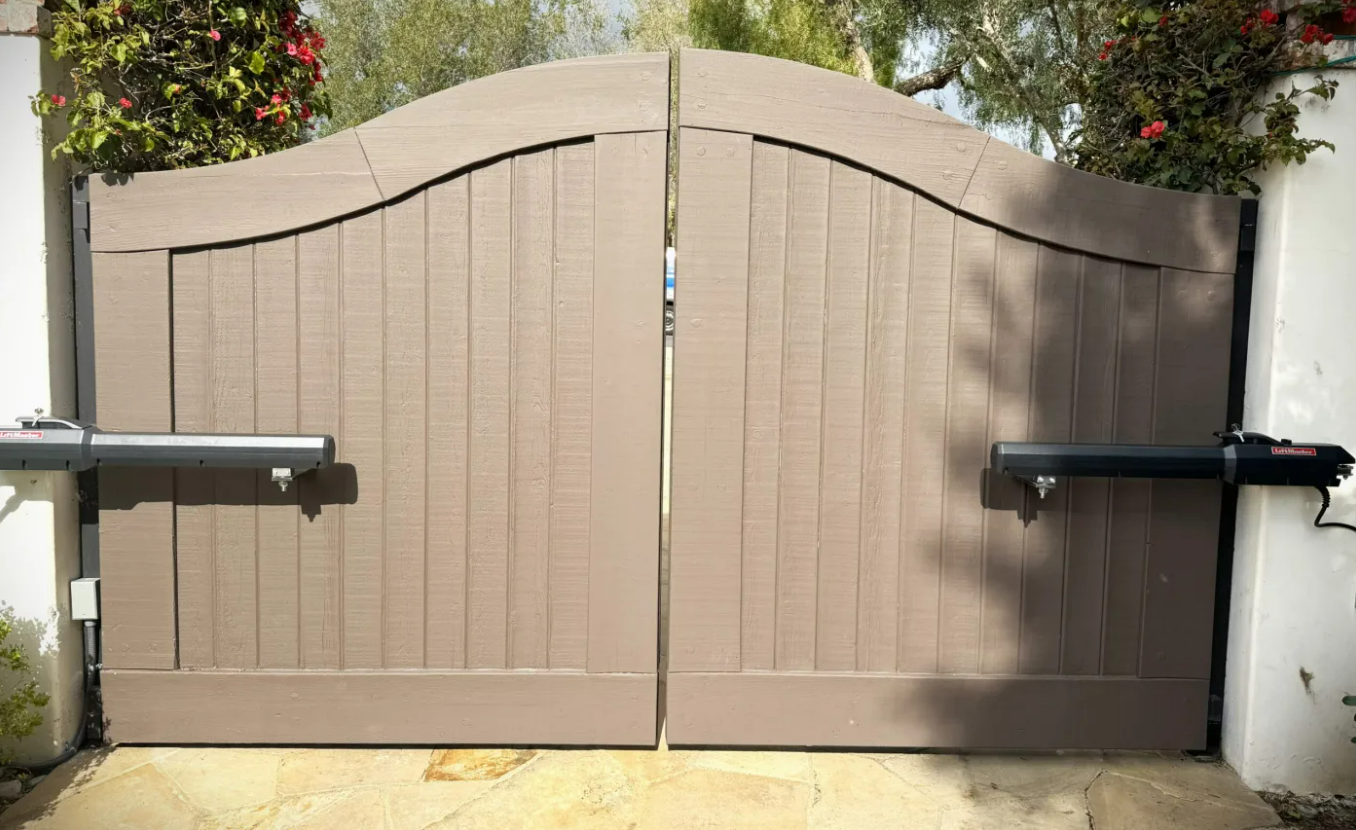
[89,50,1239,749]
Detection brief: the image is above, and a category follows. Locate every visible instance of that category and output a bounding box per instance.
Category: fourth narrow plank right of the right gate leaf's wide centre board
[857,179,914,671]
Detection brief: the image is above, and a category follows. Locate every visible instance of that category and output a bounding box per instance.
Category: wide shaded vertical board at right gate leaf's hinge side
[1139,269,1234,678]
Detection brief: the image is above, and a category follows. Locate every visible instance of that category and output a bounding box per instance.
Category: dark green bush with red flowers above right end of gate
[1075,0,1356,194]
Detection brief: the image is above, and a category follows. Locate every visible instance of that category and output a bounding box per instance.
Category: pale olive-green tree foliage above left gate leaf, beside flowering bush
[316,0,618,132]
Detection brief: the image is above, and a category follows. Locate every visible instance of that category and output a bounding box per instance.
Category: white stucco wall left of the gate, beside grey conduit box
[0,32,81,761]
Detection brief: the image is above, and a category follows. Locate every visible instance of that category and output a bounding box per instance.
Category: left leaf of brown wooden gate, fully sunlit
[91,56,669,745]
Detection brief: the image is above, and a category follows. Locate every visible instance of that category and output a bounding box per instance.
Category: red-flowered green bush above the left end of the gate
[33,0,330,174]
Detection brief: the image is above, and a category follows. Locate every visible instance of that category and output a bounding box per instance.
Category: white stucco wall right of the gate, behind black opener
[1223,69,1356,793]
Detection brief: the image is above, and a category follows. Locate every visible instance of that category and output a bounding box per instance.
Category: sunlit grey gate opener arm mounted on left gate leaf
[0,415,335,490]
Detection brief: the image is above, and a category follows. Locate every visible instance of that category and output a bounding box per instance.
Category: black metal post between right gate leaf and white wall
[1205,199,1257,754]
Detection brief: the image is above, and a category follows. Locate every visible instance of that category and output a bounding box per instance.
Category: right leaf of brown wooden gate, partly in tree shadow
[667,50,1239,749]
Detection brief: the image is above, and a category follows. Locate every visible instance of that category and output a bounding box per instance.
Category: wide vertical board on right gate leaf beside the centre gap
[667,129,753,671]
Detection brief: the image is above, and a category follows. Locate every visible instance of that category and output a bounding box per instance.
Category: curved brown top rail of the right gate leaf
[678,49,1239,271]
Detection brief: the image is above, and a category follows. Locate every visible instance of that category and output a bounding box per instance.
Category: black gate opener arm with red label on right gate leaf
[990,430,1356,498]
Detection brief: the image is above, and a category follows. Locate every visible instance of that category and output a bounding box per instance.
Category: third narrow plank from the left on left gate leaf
[255,236,301,669]
